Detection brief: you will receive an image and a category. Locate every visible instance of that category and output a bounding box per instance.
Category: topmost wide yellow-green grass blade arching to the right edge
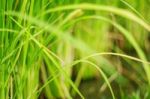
[41,3,150,31]
